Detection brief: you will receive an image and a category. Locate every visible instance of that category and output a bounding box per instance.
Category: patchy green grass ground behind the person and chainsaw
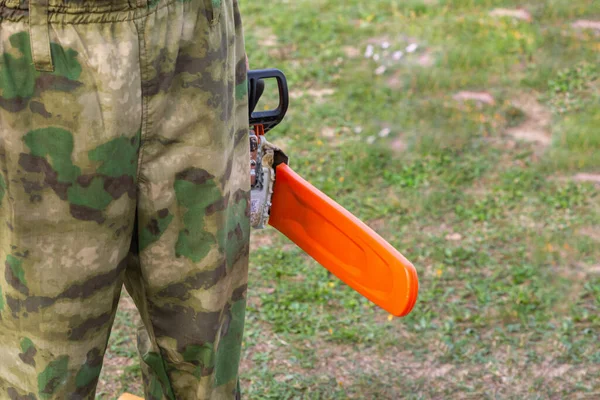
[98,0,600,399]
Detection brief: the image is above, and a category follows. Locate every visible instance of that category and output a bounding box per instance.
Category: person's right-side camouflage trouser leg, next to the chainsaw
[126,0,250,400]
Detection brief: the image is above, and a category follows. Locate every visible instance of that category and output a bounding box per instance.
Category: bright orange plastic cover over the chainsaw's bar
[269,164,419,317]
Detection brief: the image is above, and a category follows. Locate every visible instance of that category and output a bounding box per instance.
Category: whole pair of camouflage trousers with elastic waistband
[0,0,249,400]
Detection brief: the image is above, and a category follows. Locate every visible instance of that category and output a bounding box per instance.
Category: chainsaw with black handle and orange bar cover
[248,69,419,317]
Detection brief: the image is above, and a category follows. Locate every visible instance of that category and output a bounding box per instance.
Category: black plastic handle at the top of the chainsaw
[248,68,289,132]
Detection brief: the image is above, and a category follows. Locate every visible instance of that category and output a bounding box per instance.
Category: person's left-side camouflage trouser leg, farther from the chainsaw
[0,6,141,400]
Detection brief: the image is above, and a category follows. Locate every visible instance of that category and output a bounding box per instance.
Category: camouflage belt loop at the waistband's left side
[29,0,54,72]
